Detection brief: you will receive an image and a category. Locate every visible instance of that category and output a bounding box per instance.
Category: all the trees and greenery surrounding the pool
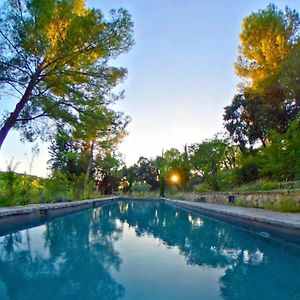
[0,0,300,210]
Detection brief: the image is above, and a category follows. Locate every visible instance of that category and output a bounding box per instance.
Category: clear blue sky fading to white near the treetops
[0,0,300,176]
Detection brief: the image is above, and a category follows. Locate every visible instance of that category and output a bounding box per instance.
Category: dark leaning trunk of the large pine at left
[0,68,41,149]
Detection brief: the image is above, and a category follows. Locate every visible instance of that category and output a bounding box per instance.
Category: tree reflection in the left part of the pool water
[0,207,124,300]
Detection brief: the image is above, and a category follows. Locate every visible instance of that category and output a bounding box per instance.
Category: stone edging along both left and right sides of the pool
[0,197,300,243]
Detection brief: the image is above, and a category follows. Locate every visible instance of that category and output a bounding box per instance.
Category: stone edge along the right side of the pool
[165,199,300,244]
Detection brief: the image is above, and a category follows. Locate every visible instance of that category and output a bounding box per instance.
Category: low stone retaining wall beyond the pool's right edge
[178,190,300,210]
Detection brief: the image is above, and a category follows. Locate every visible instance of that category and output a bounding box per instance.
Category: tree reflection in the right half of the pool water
[116,202,300,300]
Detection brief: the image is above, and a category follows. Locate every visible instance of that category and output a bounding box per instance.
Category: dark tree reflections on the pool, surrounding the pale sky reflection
[0,202,300,300]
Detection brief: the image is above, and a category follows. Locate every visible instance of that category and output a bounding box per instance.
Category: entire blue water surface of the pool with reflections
[0,202,300,300]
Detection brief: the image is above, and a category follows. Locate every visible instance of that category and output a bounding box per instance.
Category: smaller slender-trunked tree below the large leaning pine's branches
[49,106,128,191]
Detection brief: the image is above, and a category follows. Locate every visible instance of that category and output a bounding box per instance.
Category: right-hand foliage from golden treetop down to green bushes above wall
[224,4,300,180]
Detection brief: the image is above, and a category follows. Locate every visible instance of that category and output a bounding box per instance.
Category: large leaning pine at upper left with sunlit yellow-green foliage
[0,0,133,148]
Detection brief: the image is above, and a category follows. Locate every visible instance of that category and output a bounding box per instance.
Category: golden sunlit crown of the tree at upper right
[235,4,300,90]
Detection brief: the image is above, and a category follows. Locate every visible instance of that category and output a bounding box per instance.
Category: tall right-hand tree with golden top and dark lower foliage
[224,4,300,152]
